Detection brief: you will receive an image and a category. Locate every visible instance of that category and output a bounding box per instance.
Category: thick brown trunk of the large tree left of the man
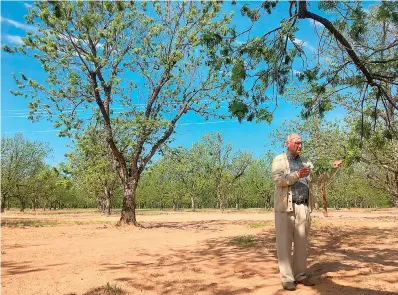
[118,179,138,226]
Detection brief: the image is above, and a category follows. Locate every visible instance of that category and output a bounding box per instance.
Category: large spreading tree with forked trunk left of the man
[4,1,231,225]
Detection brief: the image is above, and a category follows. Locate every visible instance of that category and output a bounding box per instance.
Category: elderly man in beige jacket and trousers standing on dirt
[272,134,342,291]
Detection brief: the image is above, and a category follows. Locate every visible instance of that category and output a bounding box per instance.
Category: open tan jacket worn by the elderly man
[272,153,336,212]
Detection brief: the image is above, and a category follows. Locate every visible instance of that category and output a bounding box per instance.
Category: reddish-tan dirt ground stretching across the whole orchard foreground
[1,209,398,295]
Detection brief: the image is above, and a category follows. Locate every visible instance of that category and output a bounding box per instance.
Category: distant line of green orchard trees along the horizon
[1,133,393,213]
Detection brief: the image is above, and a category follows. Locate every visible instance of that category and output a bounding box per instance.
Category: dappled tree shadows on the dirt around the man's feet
[77,221,398,295]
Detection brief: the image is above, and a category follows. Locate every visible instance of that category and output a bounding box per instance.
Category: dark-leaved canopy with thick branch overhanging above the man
[207,1,398,132]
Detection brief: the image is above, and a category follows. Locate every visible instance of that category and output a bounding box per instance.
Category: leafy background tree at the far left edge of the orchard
[0,133,50,212]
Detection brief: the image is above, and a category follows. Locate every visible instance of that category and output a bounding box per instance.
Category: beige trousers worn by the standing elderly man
[275,204,311,282]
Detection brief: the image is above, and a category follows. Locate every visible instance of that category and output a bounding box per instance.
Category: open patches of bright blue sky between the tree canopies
[1,1,354,165]
